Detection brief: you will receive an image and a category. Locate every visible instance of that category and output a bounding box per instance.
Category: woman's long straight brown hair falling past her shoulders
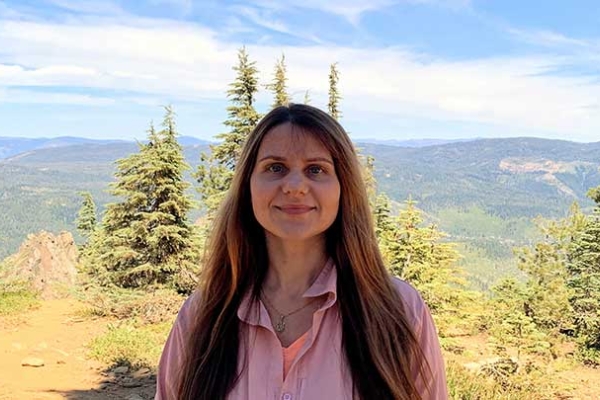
[178,104,428,400]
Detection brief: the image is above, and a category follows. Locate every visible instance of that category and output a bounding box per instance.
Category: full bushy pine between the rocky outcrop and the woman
[88,107,198,288]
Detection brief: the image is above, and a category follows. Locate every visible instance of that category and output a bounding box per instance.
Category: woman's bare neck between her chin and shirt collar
[262,235,328,300]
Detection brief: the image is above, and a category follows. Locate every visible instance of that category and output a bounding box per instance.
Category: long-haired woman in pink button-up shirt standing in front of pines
[156,104,447,400]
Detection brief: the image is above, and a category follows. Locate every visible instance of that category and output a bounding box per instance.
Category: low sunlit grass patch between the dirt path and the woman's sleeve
[89,321,172,369]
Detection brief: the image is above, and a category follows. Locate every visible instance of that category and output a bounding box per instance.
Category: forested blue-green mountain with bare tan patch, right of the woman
[362,138,600,218]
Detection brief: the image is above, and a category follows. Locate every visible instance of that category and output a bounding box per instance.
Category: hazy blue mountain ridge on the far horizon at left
[0,136,209,160]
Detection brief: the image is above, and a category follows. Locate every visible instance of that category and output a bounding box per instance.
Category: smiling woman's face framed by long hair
[250,123,340,241]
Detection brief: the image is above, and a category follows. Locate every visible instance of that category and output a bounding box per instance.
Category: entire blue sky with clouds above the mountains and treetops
[0,0,600,142]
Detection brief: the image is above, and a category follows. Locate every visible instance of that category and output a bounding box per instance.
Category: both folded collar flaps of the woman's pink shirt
[237,259,337,325]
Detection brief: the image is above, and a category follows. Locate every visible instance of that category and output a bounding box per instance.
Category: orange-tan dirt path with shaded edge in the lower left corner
[0,299,154,400]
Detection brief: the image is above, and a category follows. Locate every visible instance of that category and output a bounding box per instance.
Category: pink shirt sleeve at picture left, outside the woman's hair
[154,294,195,400]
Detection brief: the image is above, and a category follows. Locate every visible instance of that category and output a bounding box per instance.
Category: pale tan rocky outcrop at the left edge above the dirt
[1,231,78,298]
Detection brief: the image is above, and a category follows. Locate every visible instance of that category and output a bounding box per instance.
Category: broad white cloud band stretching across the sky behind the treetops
[0,13,600,140]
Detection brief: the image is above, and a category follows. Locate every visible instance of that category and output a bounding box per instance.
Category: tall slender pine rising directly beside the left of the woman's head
[194,48,260,216]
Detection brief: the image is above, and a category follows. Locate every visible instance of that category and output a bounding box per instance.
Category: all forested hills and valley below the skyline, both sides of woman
[0,138,600,287]
